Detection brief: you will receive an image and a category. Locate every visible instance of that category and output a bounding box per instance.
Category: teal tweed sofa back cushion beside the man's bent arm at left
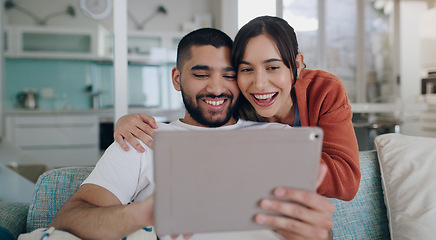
[27,167,93,232]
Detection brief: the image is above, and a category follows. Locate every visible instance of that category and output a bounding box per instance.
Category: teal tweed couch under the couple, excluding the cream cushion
[0,151,390,240]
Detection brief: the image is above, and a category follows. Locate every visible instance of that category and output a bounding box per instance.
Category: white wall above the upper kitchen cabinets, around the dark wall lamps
[2,0,216,31]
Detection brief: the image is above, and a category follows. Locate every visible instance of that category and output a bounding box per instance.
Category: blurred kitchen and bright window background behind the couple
[0,0,436,196]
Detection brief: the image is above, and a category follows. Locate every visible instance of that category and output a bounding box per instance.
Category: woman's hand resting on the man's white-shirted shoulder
[114,113,157,152]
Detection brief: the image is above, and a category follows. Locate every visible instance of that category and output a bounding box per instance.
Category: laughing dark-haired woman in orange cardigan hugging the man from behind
[114,16,360,200]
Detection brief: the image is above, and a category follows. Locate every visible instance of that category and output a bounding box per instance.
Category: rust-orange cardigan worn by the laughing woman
[294,69,360,201]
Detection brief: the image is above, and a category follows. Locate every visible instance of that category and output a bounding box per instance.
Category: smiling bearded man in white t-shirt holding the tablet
[51,28,334,240]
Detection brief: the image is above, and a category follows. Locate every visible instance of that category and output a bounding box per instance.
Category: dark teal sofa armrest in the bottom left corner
[0,202,29,239]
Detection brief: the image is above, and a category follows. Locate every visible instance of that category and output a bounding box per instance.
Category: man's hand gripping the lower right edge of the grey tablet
[254,164,335,239]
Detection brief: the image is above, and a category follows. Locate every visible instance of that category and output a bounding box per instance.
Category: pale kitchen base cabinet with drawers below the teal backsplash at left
[6,112,100,168]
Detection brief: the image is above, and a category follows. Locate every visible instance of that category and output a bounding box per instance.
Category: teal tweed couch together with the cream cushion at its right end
[0,134,436,240]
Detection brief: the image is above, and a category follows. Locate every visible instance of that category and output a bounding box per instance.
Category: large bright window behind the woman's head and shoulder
[238,0,398,102]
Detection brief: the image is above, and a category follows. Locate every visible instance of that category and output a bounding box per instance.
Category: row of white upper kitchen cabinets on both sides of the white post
[3,26,184,64]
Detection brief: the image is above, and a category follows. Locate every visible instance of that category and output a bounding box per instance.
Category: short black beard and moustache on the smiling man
[181,87,238,127]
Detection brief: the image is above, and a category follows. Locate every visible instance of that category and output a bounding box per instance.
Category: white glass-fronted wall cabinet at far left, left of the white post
[5,26,112,60]
